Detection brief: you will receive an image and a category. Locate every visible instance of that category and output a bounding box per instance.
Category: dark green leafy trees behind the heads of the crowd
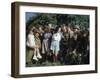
[26,13,89,28]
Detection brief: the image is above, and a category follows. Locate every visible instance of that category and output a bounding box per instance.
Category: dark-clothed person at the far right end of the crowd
[80,30,89,64]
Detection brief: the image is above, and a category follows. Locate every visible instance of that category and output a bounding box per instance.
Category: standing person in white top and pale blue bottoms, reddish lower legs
[50,27,61,62]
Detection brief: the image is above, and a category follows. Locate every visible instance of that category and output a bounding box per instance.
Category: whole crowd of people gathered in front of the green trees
[26,24,89,65]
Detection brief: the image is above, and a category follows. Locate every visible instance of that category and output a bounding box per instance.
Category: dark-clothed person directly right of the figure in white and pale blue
[60,26,69,64]
